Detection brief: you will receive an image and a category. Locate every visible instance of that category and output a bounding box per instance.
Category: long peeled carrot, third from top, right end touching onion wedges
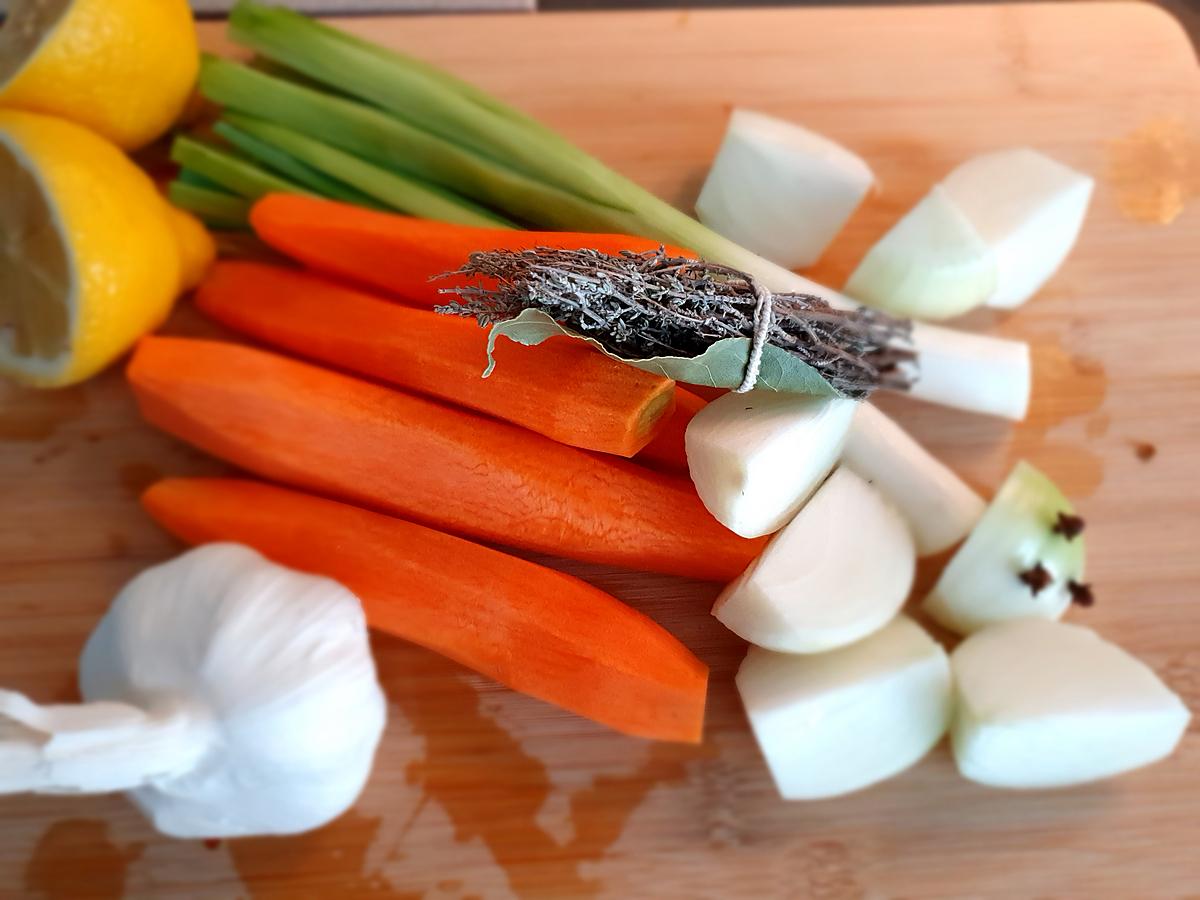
[128,337,763,580]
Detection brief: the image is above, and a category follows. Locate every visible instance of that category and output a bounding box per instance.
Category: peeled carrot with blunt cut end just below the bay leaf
[196,262,674,456]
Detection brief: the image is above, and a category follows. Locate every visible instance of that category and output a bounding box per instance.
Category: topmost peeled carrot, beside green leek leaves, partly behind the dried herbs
[250,194,695,306]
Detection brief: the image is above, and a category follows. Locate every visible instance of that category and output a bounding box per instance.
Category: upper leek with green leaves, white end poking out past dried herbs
[223,0,1030,419]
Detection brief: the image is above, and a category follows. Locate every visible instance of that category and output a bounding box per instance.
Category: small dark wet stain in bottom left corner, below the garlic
[23,818,145,900]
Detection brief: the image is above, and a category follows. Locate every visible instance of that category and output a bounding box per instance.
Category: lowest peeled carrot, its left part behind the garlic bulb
[142,479,708,742]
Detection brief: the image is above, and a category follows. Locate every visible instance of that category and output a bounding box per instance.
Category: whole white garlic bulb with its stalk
[0,544,386,838]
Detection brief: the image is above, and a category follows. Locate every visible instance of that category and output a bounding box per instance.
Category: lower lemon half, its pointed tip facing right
[0,109,215,386]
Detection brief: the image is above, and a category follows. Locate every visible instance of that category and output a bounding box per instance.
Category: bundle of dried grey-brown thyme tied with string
[438,247,914,398]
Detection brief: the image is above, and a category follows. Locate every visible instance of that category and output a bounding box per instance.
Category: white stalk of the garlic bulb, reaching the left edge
[0,690,210,794]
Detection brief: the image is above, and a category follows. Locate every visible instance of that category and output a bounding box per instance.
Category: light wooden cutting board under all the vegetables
[0,4,1200,900]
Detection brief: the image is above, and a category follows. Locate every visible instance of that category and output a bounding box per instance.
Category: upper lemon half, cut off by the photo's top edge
[0,0,199,150]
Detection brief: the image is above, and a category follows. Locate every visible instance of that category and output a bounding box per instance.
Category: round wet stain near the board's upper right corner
[1108,116,1200,224]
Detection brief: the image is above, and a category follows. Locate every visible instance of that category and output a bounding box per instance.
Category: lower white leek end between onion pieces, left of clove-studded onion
[842,403,986,557]
